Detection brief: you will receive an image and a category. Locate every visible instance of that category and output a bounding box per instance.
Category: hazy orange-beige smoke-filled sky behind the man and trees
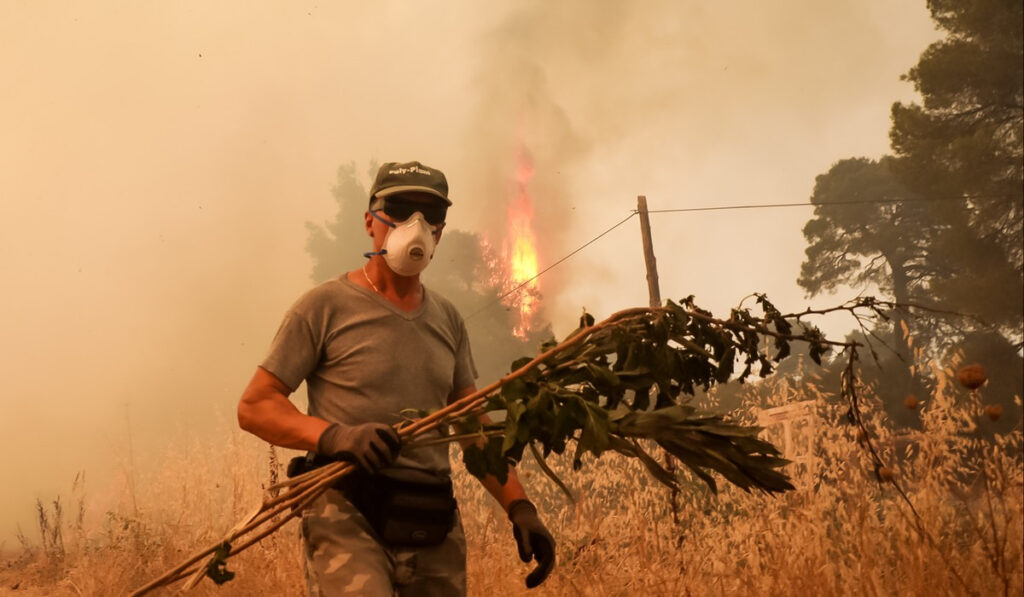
[0,0,938,545]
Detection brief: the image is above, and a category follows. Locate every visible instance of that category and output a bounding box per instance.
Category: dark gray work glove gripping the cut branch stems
[316,423,401,473]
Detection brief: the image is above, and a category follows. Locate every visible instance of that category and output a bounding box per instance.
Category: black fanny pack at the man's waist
[289,459,458,547]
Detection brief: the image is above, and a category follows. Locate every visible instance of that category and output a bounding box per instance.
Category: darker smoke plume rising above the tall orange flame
[465,2,643,319]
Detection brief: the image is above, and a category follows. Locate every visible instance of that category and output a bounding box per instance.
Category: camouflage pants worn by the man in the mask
[302,489,466,597]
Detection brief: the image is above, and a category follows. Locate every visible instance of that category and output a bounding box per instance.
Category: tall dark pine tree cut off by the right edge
[890,0,1024,331]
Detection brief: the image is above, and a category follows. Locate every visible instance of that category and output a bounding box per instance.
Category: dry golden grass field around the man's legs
[0,370,1024,596]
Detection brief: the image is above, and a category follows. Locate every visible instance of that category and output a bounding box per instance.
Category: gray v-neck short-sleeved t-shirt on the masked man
[260,275,476,473]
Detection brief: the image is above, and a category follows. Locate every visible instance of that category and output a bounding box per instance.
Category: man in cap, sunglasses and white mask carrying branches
[239,162,554,596]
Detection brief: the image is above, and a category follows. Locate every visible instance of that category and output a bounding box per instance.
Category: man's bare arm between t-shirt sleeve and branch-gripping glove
[239,367,329,452]
